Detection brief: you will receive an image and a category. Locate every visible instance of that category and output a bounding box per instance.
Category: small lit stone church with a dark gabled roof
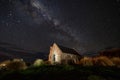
[48,43,82,64]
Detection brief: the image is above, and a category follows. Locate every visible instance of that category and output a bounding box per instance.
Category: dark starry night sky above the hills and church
[0,0,120,53]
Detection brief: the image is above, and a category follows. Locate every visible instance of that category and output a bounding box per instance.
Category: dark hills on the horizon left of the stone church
[0,42,47,62]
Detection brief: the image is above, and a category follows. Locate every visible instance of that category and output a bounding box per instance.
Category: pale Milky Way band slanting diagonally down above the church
[20,0,80,50]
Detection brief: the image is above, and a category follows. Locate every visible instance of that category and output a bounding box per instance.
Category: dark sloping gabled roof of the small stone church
[57,45,81,56]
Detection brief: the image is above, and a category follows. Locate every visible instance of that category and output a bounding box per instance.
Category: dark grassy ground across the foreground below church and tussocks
[0,65,120,80]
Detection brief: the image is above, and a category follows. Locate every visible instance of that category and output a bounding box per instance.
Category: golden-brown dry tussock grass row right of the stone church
[79,56,116,66]
